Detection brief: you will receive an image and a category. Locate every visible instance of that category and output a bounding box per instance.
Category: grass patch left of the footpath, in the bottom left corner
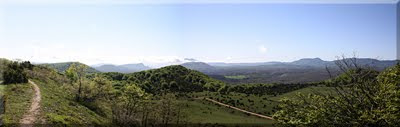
[2,83,34,124]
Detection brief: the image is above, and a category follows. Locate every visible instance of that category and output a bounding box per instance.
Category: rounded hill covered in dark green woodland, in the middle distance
[101,65,225,94]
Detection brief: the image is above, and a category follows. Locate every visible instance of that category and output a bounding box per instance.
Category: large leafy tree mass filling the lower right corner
[273,58,400,126]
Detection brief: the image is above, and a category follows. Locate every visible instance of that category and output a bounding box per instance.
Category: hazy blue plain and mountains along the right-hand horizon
[182,58,397,83]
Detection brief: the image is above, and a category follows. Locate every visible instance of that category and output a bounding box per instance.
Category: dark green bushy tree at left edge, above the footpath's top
[3,62,28,84]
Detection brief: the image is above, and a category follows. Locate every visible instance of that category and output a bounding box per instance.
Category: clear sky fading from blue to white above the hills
[0,1,396,66]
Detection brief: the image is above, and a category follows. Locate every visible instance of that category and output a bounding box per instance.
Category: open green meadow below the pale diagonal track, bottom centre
[181,100,274,126]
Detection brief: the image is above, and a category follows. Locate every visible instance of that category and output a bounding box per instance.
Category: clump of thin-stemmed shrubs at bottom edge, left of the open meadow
[112,84,187,126]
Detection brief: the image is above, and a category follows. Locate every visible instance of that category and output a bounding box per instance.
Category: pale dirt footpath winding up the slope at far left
[20,80,42,127]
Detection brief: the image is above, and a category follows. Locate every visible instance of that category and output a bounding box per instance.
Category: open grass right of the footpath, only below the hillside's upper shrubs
[33,80,110,126]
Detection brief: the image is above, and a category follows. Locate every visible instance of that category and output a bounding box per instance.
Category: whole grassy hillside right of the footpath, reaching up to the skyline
[31,67,110,125]
